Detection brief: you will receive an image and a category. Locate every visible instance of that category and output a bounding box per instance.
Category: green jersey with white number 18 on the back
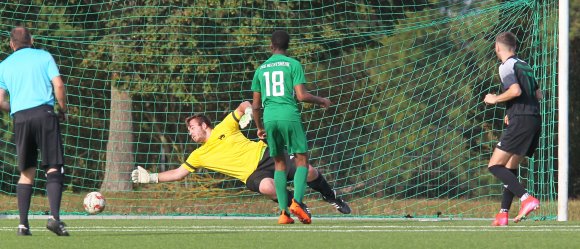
[252,54,306,123]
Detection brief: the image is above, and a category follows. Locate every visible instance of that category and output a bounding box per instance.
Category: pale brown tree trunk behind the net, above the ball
[101,75,134,192]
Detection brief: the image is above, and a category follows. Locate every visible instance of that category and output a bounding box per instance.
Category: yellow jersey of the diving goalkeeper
[181,111,267,183]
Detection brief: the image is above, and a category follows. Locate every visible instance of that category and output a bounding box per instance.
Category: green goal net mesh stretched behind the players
[0,0,558,218]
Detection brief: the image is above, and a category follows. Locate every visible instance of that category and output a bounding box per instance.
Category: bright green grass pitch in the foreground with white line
[0,217,580,249]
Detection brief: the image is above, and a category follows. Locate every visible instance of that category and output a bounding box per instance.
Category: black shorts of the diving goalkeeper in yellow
[246,149,296,193]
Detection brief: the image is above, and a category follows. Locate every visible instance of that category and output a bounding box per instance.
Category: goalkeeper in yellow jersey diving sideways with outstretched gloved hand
[131,101,351,214]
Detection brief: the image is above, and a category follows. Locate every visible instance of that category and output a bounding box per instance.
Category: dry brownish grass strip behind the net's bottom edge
[0,192,580,221]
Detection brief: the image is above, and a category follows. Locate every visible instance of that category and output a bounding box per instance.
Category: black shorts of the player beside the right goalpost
[496,115,542,157]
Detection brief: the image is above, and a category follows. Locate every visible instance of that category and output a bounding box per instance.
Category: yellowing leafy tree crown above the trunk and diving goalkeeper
[82,1,426,191]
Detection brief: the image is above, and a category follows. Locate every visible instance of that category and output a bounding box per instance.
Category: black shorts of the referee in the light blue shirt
[13,105,64,171]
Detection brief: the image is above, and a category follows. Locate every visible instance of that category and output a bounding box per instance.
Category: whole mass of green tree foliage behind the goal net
[0,0,560,197]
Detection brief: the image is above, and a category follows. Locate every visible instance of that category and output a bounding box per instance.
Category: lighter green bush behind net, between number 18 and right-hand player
[330,0,498,197]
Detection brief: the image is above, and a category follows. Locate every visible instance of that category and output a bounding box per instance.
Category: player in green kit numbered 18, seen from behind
[252,30,331,224]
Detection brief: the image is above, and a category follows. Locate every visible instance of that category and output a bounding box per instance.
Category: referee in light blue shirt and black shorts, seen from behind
[0,27,69,236]
